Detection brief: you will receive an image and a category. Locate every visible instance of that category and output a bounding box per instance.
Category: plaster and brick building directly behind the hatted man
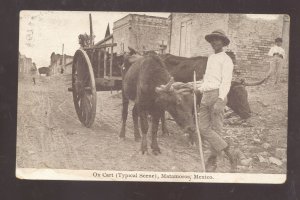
[169,13,289,77]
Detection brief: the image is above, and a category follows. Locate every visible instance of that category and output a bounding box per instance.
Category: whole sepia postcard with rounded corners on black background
[16,10,290,184]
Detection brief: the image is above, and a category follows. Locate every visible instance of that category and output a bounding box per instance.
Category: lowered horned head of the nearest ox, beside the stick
[155,78,196,138]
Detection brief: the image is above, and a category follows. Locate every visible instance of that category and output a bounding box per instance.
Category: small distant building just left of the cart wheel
[49,52,73,75]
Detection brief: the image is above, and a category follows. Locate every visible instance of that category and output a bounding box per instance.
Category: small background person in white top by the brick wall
[268,38,285,84]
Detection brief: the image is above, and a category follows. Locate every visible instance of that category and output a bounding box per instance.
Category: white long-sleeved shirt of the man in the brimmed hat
[198,51,233,100]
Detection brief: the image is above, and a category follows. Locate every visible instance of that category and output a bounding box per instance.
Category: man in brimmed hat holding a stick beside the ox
[198,30,237,172]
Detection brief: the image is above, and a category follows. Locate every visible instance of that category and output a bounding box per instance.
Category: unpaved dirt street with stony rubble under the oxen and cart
[17,76,287,173]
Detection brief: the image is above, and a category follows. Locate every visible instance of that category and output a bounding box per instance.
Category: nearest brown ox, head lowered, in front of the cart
[120,55,195,154]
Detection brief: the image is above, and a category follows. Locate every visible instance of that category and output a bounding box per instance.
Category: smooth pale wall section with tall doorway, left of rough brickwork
[170,13,228,57]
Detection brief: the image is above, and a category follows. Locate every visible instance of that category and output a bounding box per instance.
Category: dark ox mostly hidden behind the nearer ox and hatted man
[120,48,270,139]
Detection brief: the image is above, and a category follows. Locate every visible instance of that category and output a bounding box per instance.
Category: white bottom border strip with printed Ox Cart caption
[16,168,286,184]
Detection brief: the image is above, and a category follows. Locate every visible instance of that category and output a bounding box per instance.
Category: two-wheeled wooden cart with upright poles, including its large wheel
[68,15,122,127]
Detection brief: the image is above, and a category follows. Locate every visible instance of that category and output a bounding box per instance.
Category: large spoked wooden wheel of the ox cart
[72,49,97,127]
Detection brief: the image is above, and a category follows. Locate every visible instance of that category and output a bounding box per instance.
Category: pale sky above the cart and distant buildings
[19,11,170,68]
